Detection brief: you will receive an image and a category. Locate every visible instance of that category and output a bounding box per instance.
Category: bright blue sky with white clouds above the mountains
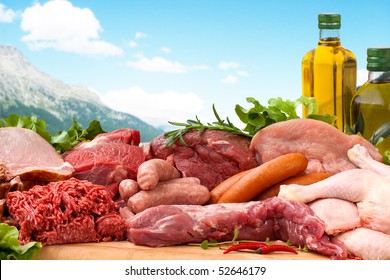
[0,0,390,126]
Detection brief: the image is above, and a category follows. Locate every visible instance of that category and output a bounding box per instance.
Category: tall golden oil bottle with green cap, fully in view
[302,14,356,131]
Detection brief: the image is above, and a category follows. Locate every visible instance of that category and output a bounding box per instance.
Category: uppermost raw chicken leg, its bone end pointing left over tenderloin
[278,169,390,234]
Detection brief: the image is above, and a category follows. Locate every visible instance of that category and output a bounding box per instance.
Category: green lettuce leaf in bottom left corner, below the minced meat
[0,223,42,260]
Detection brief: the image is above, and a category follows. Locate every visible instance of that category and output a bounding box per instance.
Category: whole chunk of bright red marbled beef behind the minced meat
[63,129,145,196]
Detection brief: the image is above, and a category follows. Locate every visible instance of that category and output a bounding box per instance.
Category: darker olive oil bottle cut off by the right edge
[351,47,390,155]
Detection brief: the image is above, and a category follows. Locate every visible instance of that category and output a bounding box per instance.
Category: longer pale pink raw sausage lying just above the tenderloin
[127,177,210,213]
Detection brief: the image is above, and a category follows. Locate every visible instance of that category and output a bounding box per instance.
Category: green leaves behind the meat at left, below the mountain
[0,114,105,153]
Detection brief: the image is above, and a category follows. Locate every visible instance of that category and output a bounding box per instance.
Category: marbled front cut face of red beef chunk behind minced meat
[64,142,145,195]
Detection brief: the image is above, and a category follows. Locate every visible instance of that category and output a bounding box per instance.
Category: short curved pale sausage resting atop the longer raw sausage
[137,158,181,190]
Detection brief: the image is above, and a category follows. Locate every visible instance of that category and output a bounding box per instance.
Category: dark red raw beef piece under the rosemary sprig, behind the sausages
[150,129,258,190]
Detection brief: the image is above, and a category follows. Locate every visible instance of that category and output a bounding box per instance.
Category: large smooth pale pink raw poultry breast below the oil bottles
[250,118,382,174]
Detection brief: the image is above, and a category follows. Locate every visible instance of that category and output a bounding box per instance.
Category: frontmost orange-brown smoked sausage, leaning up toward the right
[218,153,308,203]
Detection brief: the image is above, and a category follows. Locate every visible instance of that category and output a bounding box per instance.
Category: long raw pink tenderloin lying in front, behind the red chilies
[126,197,347,259]
